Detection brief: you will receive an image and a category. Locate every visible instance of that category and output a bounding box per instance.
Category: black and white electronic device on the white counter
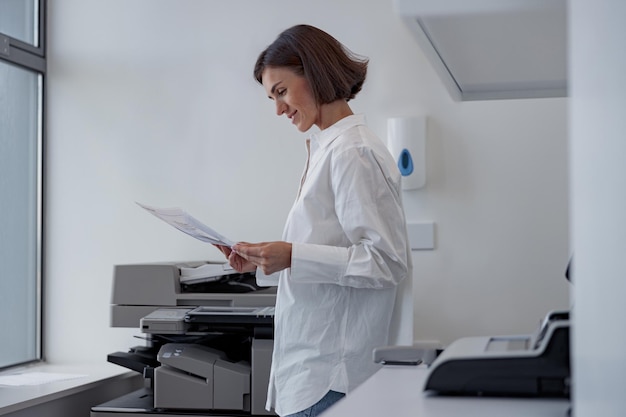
[424,311,571,397]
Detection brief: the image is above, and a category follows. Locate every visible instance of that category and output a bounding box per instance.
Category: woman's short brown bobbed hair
[254,25,369,104]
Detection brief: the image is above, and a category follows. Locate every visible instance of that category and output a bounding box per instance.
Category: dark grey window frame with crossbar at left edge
[0,0,47,370]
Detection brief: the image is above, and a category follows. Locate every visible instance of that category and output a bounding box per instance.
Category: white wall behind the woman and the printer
[45,0,569,361]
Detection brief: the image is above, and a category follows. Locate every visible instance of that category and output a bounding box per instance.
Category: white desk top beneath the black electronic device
[323,365,570,417]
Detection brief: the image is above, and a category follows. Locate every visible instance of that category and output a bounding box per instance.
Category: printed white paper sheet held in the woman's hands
[137,203,235,247]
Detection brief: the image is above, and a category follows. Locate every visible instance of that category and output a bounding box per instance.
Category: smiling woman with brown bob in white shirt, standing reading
[220,25,411,416]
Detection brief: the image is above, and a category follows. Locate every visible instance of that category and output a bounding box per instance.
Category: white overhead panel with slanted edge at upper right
[395,0,567,100]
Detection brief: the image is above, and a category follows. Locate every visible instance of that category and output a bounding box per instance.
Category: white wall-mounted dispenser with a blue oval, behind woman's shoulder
[387,116,426,190]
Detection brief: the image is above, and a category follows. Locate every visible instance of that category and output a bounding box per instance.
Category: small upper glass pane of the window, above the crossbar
[0,0,39,46]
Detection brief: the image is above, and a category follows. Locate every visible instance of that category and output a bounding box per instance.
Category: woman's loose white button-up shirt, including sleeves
[259,115,411,415]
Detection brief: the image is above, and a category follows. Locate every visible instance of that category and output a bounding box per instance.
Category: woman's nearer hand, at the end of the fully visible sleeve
[228,242,291,275]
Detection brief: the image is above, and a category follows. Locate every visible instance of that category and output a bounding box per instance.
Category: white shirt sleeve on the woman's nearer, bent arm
[291,147,409,288]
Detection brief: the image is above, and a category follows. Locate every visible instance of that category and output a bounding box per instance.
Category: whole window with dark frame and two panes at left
[0,0,46,368]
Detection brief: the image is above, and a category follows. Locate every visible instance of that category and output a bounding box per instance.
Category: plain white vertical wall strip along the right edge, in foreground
[569,0,626,417]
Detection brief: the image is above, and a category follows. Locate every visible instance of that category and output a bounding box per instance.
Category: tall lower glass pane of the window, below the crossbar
[0,59,41,368]
